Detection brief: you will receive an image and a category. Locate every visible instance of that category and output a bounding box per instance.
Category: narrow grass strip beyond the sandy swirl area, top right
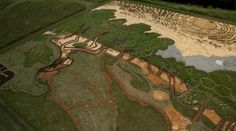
[129,0,236,25]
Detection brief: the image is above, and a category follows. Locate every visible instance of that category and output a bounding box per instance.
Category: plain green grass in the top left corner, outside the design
[0,0,86,49]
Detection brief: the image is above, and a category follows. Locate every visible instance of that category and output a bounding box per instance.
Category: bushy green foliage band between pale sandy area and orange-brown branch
[58,10,236,122]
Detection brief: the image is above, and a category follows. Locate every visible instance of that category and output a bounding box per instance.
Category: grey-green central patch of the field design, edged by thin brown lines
[51,52,117,131]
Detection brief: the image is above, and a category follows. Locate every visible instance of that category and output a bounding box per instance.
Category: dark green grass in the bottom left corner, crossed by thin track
[0,91,76,131]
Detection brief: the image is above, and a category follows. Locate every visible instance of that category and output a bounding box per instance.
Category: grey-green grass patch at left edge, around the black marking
[0,37,59,95]
